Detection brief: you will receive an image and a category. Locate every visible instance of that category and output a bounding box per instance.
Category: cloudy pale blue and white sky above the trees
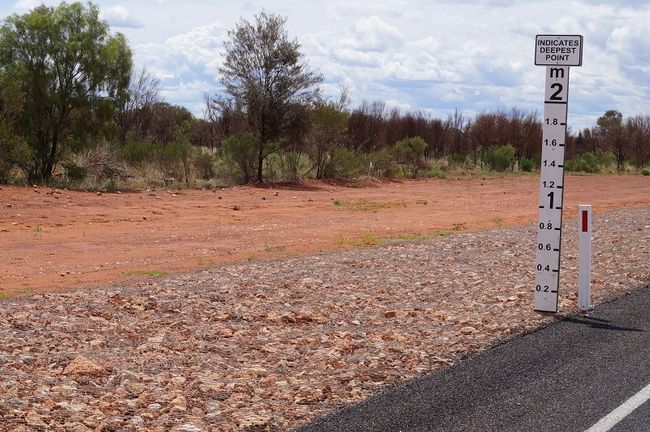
[0,0,650,130]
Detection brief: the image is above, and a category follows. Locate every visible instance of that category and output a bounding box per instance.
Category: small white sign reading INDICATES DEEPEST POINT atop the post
[535,35,582,66]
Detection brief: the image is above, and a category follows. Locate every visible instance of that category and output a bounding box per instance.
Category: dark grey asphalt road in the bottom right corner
[299,285,650,432]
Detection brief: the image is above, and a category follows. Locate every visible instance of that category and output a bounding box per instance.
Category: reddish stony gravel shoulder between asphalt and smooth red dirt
[0,206,650,431]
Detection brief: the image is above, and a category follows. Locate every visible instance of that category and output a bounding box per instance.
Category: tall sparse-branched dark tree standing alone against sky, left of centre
[219,12,323,182]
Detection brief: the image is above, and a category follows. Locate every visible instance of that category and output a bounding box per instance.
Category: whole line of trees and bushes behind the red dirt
[0,3,650,184]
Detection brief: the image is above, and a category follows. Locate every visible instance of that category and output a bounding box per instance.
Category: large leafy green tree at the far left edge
[0,3,131,183]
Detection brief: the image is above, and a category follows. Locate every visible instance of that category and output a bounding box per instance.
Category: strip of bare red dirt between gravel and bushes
[0,175,650,297]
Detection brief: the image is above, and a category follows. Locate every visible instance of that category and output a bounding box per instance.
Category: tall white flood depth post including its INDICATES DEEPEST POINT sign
[534,35,582,312]
